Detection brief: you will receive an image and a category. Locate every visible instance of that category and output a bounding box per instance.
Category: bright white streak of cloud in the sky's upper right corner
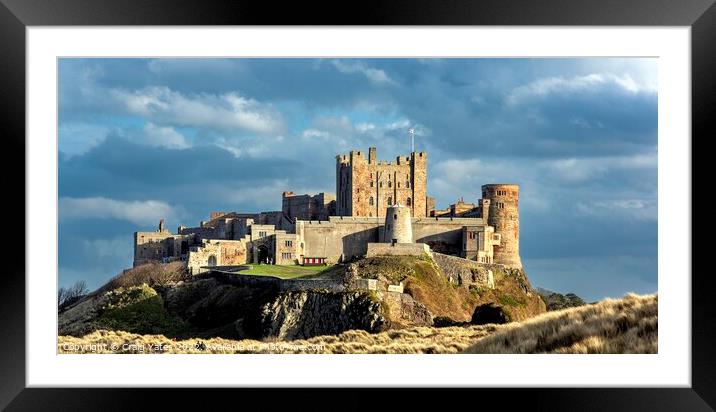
[506,73,657,105]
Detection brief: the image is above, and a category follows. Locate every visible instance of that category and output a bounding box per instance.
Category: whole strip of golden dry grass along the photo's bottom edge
[58,295,657,354]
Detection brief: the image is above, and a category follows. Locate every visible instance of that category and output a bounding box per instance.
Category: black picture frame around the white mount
[0,0,716,411]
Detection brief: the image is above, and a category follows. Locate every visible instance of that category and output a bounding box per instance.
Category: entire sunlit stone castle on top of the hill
[134,147,522,273]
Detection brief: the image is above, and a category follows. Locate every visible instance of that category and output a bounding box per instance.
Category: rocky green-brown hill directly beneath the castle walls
[58,254,545,340]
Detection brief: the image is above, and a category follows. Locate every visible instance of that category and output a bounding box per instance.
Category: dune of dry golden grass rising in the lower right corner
[465,294,658,353]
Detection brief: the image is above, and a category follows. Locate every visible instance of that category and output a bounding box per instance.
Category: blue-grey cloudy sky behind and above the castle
[58,58,657,300]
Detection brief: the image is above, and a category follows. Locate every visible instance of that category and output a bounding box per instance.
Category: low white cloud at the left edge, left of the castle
[59,197,183,225]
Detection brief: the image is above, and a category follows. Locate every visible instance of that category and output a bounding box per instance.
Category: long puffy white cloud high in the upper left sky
[110,87,284,134]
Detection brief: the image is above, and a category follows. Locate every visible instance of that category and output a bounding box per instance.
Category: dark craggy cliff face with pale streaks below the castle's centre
[261,291,386,340]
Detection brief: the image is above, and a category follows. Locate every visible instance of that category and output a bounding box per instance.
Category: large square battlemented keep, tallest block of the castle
[336,147,432,217]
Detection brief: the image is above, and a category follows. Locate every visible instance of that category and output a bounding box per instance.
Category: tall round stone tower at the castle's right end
[482,184,522,268]
